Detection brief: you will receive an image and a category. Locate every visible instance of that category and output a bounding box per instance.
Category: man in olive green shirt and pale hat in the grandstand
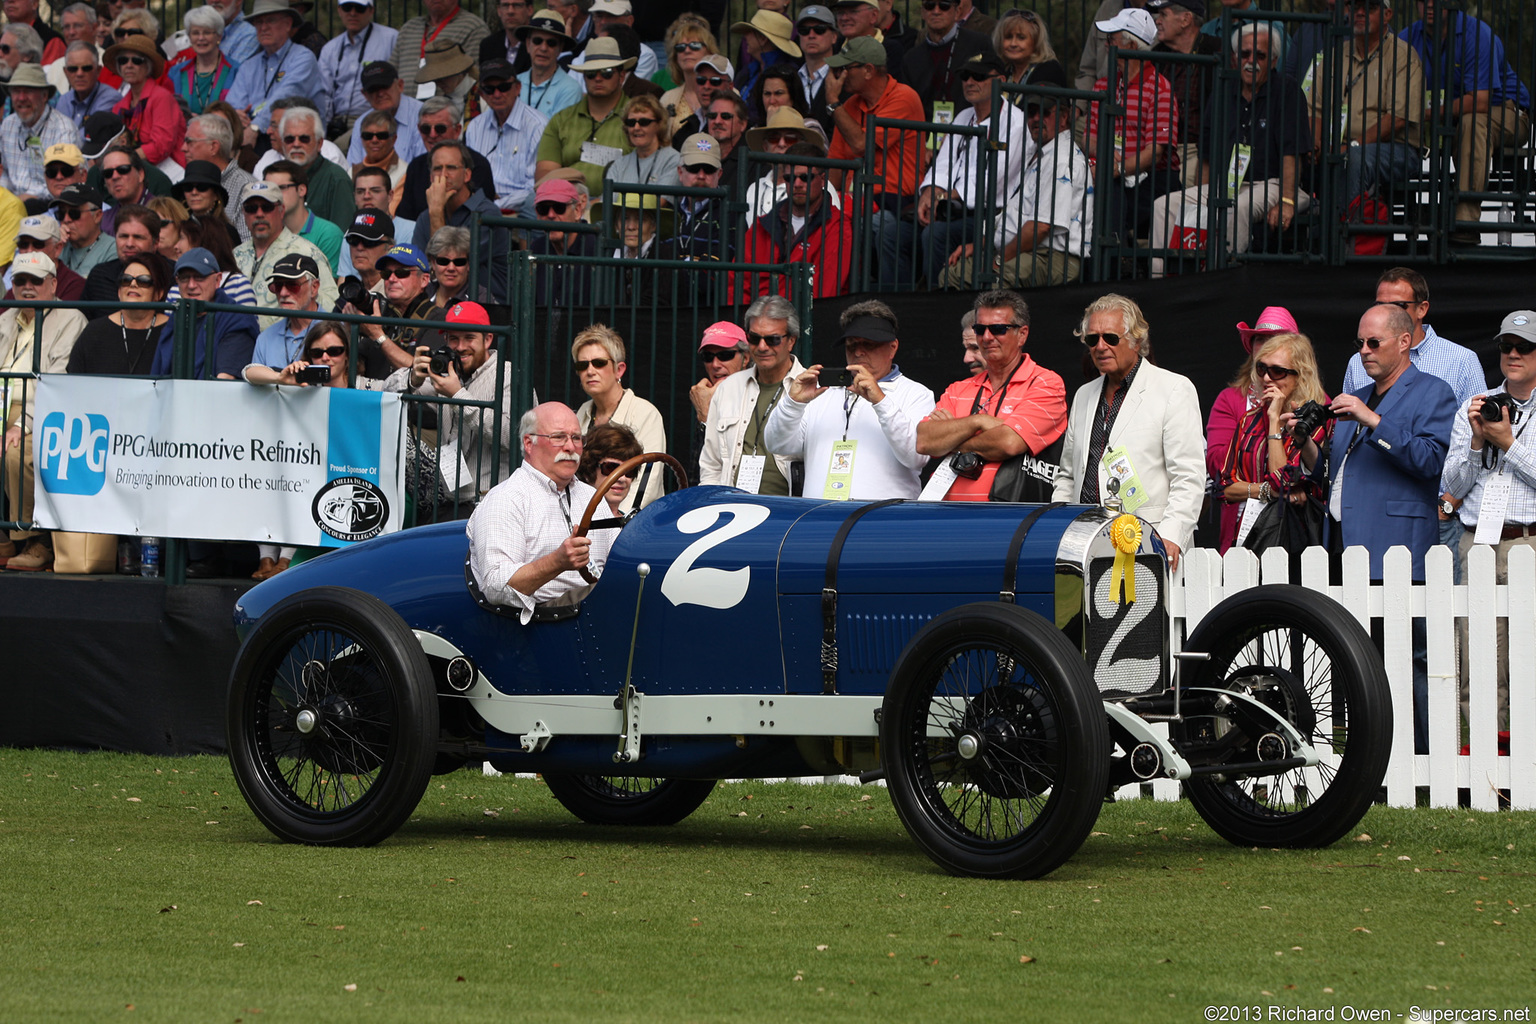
[535,37,634,195]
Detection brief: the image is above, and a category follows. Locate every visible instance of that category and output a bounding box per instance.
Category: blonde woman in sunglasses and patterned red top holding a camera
[1221,332,1332,550]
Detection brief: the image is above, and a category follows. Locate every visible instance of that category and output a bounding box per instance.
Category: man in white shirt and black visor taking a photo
[763,299,934,500]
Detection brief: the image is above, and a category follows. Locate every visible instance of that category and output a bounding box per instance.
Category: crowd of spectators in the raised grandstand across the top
[0,0,1511,320]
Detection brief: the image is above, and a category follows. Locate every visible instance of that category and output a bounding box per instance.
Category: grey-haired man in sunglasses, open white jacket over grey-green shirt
[699,295,805,494]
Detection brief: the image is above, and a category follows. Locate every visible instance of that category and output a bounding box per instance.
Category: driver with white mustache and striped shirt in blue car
[465,402,614,623]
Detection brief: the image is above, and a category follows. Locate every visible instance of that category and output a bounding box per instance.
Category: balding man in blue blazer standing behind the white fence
[1301,302,1456,754]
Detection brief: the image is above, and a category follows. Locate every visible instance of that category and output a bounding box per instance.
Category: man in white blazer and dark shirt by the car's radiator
[1056,295,1206,570]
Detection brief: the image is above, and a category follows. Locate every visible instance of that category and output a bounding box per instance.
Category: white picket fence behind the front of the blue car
[1173,545,1536,811]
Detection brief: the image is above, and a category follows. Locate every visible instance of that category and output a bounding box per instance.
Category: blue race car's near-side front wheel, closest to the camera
[880,603,1111,878]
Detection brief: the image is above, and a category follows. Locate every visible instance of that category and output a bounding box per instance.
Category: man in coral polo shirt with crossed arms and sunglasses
[917,290,1066,502]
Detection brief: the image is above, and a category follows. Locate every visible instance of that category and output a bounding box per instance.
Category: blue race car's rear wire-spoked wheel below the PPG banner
[227,586,438,846]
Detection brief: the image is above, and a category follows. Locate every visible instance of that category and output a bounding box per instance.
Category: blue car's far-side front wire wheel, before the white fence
[1172,585,1392,847]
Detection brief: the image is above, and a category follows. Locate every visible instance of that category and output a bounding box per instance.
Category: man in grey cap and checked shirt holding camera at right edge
[1441,310,1536,739]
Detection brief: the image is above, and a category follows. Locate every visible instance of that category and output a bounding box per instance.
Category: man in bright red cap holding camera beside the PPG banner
[384,300,513,494]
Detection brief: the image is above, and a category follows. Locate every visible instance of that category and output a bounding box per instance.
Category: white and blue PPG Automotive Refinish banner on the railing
[32,375,406,547]
